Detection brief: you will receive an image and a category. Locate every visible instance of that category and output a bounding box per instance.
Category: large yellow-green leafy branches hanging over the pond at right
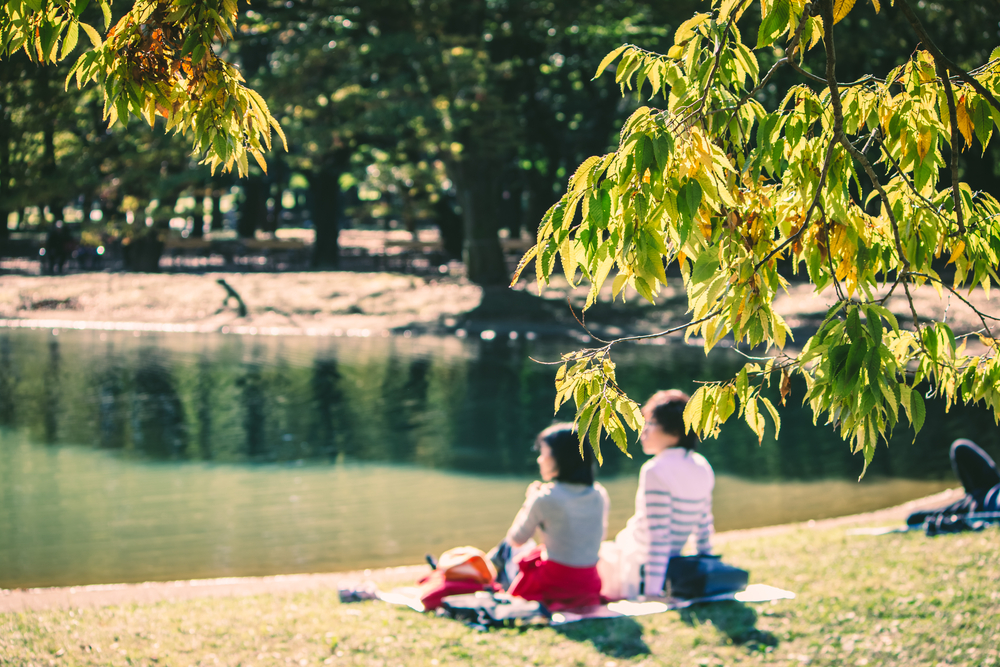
[519,0,1000,474]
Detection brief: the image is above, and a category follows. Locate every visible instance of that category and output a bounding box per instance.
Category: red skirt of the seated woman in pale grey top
[507,547,601,611]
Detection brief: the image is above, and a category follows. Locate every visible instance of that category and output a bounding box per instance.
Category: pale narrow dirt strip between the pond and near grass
[0,489,964,614]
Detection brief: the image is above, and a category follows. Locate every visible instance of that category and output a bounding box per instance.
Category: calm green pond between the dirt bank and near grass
[0,329,998,588]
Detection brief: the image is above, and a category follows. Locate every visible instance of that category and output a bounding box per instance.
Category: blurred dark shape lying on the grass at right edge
[906,438,1000,536]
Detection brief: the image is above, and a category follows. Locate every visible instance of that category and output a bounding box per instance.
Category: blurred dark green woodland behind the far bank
[0,0,1000,284]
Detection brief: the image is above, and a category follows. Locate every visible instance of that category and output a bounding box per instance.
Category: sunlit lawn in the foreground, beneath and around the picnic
[0,527,1000,666]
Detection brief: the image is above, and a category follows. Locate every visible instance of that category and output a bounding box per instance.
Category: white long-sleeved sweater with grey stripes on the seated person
[617,447,715,595]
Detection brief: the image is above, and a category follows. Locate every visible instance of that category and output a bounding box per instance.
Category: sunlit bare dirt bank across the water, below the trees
[0,272,996,343]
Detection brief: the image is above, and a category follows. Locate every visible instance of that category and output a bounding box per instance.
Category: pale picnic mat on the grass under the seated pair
[374,584,795,625]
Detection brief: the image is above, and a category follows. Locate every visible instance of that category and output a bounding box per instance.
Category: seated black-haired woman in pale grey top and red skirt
[505,424,610,610]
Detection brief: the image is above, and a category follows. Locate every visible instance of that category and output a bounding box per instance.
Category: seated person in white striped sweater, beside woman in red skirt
[615,389,715,597]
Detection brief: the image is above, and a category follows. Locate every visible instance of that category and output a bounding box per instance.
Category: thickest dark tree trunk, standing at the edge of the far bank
[453,161,510,285]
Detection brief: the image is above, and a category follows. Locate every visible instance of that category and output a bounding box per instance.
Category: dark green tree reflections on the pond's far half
[0,332,1000,480]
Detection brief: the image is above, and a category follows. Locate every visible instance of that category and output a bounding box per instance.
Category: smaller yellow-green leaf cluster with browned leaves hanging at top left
[0,0,284,175]
